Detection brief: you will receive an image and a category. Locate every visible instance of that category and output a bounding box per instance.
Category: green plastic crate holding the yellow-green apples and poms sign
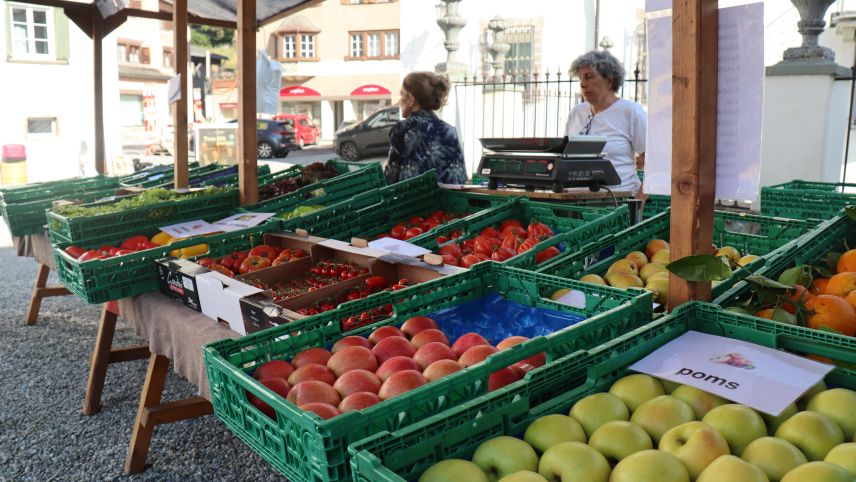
[349,302,856,482]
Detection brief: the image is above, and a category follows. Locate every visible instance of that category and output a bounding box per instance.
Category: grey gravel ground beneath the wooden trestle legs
[0,248,282,482]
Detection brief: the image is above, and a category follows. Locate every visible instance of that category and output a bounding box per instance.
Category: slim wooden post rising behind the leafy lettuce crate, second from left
[172,0,189,189]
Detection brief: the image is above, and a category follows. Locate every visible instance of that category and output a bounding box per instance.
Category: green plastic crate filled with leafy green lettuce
[47,189,238,244]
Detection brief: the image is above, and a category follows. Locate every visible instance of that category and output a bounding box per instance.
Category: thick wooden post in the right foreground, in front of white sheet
[669,0,719,308]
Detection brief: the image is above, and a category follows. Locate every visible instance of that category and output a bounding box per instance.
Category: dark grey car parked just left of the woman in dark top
[333,106,401,161]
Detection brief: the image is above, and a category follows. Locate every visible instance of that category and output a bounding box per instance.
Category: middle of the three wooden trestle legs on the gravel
[83,303,149,415]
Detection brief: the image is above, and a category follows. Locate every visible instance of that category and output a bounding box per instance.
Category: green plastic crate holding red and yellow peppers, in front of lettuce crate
[53,221,280,304]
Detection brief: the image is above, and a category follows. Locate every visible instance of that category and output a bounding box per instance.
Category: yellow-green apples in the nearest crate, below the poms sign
[419,374,856,482]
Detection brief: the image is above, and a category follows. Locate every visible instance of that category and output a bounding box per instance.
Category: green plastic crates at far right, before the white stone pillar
[761,180,856,219]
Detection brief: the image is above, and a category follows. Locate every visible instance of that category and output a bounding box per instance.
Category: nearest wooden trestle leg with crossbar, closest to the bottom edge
[125,353,213,474]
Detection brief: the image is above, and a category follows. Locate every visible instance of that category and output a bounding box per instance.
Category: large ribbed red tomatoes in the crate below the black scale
[437,219,559,268]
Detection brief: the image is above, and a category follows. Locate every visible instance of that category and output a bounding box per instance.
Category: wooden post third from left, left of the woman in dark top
[237,0,259,205]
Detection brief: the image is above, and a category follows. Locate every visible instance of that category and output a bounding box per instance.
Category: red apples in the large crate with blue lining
[247,316,546,424]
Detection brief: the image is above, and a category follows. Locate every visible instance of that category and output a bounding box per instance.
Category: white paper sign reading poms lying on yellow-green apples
[630,331,833,416]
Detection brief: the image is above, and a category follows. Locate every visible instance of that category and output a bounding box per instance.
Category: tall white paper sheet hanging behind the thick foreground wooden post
[644,3,764,201]
